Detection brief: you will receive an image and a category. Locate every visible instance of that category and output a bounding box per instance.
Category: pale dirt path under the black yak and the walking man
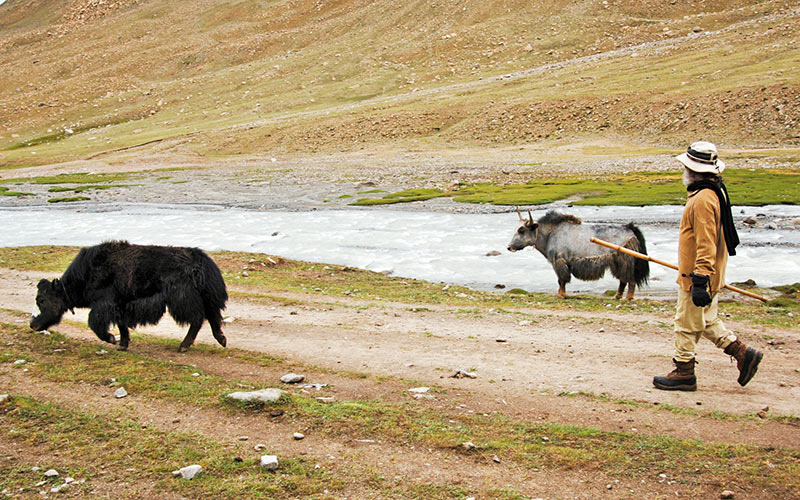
[0,270,800,449]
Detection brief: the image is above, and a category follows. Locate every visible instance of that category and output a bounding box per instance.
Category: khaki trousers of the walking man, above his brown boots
[675,289,736,363]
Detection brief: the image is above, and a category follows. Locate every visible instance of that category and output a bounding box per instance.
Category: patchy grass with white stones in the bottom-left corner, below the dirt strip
[0,396,344,499]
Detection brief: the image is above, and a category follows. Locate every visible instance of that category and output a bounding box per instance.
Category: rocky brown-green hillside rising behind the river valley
[0,0,800,166]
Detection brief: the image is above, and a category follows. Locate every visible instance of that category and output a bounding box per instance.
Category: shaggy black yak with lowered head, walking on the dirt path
[30,241,228,352]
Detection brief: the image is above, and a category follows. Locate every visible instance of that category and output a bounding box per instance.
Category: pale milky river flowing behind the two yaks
[0,204,800,294]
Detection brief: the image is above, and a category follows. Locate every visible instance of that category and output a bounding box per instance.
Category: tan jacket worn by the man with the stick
[678,189,728,292]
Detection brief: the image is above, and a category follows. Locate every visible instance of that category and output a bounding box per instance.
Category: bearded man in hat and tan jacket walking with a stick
[653,141,762,391]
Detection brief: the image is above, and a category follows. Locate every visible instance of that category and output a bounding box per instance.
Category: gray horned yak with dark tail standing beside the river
[508,209,650,300]
